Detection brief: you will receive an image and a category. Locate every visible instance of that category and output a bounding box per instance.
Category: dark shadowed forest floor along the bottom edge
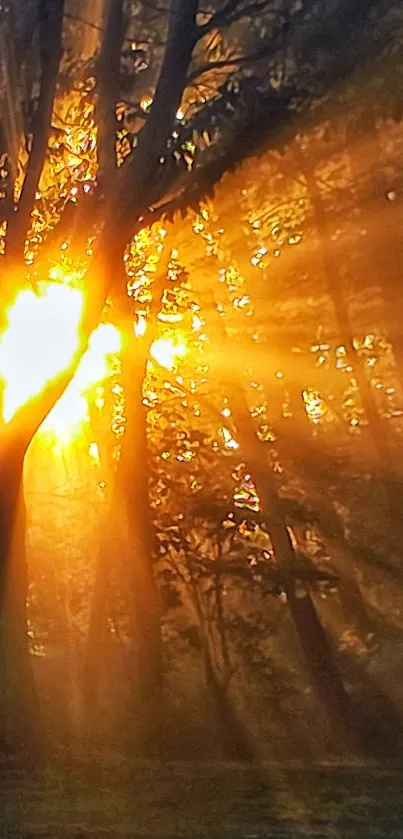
[0,761,403,839]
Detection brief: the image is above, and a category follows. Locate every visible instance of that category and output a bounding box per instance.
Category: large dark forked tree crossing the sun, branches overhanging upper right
[0,0,394,748]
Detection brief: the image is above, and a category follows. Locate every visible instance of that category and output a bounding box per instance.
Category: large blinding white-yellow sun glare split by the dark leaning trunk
[0,282,121,441]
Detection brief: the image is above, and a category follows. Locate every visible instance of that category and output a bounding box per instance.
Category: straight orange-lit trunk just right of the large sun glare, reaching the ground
[119,319,162,752]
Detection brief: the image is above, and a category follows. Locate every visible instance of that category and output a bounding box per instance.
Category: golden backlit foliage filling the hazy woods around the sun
[0,0,402,756]
